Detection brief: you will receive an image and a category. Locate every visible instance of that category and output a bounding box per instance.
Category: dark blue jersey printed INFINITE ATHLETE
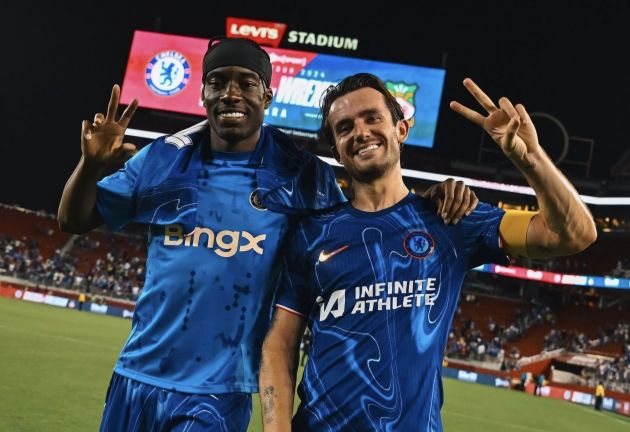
[276,194,507,431]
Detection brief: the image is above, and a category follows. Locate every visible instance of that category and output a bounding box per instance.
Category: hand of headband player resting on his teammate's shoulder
[422,178,479,225]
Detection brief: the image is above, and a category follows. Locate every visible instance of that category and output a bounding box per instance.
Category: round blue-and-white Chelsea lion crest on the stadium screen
[145,50,190,96]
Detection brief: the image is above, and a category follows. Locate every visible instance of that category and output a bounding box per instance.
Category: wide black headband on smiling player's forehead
[201,38,271,88]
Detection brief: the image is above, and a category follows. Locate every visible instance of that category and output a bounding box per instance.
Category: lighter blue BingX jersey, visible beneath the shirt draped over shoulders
[97,148,290,394]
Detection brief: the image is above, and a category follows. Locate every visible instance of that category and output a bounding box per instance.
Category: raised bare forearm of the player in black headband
[57,158,104,234]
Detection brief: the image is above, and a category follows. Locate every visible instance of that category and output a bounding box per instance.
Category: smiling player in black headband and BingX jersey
[59,39,476,431]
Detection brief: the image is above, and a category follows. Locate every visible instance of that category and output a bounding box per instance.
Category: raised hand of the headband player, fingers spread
[81,84,138,166]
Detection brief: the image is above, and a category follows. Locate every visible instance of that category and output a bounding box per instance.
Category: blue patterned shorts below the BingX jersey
[100,373,252,432]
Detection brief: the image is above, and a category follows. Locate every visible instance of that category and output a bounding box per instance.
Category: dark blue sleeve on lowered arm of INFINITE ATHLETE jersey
[275,228,315,318]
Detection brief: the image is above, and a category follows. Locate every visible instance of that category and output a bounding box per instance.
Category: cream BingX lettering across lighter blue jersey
[164,224,267,258]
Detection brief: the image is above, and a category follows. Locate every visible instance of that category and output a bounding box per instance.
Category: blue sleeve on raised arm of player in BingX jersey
[96,144,151,229]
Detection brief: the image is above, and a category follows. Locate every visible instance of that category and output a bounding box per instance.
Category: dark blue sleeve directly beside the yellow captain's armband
[460,203,509,268]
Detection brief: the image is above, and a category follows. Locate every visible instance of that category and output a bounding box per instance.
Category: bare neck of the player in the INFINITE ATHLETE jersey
[352,167,409,212]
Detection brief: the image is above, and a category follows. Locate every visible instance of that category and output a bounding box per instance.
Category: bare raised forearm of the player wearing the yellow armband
[516,149,597,257]
